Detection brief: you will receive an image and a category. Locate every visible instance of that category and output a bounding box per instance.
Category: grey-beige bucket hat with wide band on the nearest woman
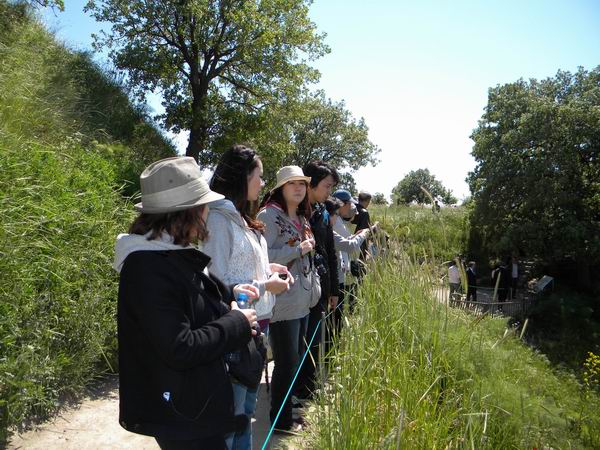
[135,156,225,214]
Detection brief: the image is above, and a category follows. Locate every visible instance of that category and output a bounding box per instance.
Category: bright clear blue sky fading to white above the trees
[45,0,600,198]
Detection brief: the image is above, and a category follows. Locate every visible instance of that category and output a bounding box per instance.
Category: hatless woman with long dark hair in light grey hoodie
[202,145,293,450]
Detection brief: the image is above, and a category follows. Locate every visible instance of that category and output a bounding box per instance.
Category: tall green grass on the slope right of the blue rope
[303,251,600,449]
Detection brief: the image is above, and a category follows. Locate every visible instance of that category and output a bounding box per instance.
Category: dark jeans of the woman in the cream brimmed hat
[269,317,307,430]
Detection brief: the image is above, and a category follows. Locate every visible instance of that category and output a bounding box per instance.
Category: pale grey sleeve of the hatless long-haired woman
[202,212,233,280]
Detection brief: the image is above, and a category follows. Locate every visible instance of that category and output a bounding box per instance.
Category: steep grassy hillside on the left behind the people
[0,1,174,447]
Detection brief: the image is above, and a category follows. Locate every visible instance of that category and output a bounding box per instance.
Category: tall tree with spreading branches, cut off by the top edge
[86,0,329,163]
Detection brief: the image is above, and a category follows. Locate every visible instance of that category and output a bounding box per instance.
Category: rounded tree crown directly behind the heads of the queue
[210,91,380,185]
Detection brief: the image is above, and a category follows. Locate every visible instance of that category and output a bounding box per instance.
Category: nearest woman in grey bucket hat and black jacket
[113,157,259,449]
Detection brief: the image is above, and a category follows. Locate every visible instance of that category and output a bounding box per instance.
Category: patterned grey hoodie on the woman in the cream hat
[257,204,321,322]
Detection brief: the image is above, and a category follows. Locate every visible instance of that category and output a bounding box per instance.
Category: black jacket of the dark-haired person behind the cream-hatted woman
[310,203,340,305]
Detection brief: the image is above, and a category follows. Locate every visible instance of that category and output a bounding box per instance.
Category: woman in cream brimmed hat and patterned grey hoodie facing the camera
[258,166,321,432]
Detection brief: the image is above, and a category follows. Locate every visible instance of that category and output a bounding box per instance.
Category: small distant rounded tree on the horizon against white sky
[392,169,457,204]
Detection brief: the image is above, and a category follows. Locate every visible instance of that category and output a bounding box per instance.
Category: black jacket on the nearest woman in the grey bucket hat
[118,249,251,440]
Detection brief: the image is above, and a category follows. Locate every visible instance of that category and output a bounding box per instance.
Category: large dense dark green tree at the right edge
[467,67,600,287]
